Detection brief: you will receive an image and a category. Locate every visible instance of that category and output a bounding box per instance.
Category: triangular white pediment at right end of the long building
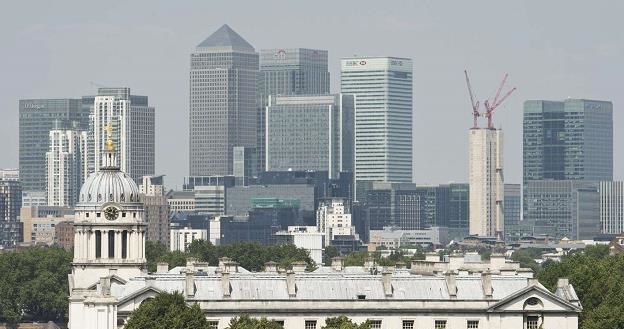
[488,285,581,313]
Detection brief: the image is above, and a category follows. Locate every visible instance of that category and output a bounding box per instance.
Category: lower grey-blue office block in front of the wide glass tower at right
[524,180,601,240]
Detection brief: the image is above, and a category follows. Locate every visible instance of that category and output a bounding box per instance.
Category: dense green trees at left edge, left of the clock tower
[0,247,72,323]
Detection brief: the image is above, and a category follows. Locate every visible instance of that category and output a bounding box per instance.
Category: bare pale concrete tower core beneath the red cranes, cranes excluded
[468,128,504,237]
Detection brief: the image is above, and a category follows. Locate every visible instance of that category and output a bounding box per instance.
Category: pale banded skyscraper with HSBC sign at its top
[340,57,412,198]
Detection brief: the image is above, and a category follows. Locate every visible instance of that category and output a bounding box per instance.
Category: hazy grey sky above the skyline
[0,0,624,187]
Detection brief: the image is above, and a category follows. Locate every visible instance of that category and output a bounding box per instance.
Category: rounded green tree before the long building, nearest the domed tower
[124,292,209,329]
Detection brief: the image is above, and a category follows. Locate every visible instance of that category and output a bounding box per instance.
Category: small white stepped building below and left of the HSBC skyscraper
[316,198,355,246]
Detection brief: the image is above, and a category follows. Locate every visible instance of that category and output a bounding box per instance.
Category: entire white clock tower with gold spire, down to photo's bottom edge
[69,125,147,329]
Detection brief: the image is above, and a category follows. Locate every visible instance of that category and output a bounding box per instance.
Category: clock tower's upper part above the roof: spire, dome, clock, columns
[72,125,146,289]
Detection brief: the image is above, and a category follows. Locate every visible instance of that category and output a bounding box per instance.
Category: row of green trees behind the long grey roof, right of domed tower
[145,240,316,272]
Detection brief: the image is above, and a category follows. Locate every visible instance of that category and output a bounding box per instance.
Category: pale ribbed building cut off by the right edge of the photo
[599,181,624,234]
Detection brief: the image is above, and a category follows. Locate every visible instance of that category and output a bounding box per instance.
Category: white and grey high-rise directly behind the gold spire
[83,87,156,182]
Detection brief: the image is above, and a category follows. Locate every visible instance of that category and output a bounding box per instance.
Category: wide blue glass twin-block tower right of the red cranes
[523,99,613,185]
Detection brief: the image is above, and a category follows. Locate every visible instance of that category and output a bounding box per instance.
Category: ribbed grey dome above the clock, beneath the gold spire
[79,170,139,205]
